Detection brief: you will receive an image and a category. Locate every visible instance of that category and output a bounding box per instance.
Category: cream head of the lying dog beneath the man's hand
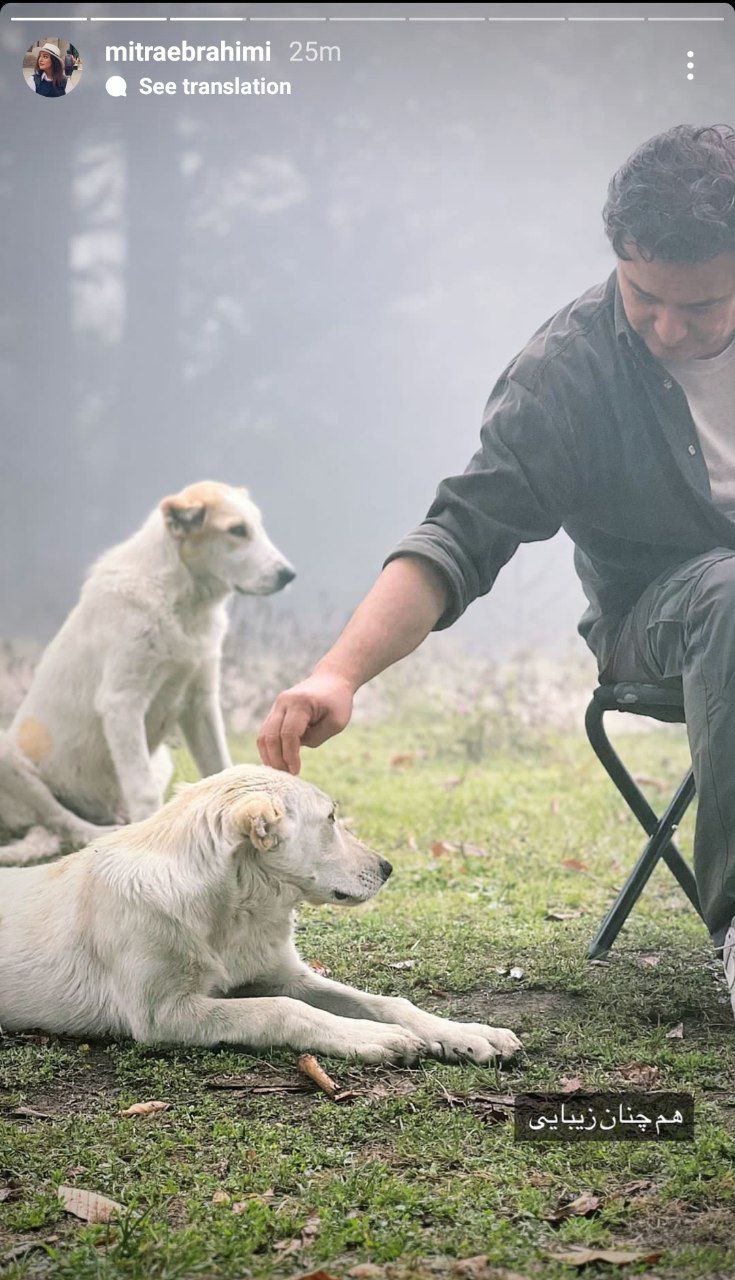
[198,765,393,906]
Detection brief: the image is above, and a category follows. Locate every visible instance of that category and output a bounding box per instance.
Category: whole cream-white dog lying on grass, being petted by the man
[0,765,520,1064]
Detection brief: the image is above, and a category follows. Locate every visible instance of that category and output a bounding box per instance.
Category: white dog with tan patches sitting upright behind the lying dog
[0,481,295,861]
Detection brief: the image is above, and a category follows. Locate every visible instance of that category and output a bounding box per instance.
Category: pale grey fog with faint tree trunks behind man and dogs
[0,4,735,655]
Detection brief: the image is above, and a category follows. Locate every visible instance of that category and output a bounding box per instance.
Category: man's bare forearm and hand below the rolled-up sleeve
[257,556,448,773]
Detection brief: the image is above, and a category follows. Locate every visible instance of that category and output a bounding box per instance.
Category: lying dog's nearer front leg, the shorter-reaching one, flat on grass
[138,996,423,1062]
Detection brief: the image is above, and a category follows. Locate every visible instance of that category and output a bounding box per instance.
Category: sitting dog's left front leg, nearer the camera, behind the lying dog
[96,687,163,822]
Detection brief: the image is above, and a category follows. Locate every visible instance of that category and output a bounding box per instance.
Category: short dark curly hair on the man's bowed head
[602,124,735,262]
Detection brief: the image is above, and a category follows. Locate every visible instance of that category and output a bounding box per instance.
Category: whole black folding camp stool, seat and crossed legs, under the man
[585,684,702,960]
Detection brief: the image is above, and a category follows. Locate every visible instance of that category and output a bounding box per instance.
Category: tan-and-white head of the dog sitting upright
[159,480,296,595]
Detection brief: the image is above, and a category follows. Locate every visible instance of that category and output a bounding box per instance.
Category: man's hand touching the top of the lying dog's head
[257,672,355,773]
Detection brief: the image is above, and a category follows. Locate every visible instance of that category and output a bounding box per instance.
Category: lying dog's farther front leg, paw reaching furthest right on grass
[272,965,521,1064]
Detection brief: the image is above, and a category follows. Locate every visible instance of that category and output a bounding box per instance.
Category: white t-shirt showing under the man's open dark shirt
[659,339,735,520]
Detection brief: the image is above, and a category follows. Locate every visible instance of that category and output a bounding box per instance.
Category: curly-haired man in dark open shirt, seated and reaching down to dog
[259,124,735,1009]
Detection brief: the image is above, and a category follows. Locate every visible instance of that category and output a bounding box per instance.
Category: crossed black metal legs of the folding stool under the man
[585,700,702,959]
